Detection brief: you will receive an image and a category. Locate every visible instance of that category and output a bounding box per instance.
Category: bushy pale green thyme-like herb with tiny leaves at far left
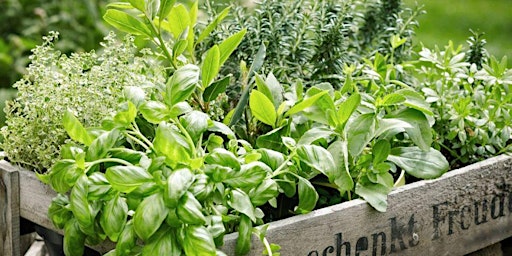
[1,33,163,171]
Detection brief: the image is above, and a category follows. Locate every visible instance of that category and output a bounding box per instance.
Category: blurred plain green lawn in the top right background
[404,0,512,59]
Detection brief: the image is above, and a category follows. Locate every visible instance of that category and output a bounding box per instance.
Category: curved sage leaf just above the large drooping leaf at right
[394,109,432,151]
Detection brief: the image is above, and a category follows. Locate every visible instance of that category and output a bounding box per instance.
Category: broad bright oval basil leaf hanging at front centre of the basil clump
[133,193,169,242]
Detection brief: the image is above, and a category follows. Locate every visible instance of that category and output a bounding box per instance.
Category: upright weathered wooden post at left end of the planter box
[0,159,20,256]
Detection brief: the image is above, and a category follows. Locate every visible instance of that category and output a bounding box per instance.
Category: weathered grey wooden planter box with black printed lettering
[0,155,512,256]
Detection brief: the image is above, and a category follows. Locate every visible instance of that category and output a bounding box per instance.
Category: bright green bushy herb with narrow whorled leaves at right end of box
[414,37,512,168]
